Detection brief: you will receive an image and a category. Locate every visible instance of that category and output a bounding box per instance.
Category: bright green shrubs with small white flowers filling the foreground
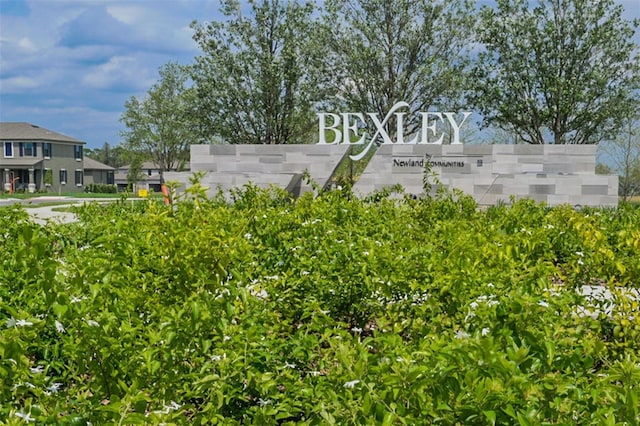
[0,185,640,425]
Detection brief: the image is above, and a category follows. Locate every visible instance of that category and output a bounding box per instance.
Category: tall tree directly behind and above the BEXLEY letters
[325,0,474,135]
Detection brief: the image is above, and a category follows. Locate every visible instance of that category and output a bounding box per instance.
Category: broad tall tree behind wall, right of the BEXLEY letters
[472,0,640,144]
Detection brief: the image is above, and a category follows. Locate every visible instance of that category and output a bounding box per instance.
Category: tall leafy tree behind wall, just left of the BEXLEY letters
[192,0,325,144]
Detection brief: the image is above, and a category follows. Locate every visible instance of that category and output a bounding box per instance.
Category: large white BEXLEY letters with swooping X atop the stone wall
[318,102,471,161]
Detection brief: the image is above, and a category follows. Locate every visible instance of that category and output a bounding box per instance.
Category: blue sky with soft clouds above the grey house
[0,0,640,148]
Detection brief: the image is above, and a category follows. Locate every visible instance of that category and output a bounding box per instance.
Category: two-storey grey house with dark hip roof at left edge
[0,122,85,192]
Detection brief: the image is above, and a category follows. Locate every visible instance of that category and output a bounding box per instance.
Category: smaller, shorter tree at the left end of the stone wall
[120,62,196,178]
